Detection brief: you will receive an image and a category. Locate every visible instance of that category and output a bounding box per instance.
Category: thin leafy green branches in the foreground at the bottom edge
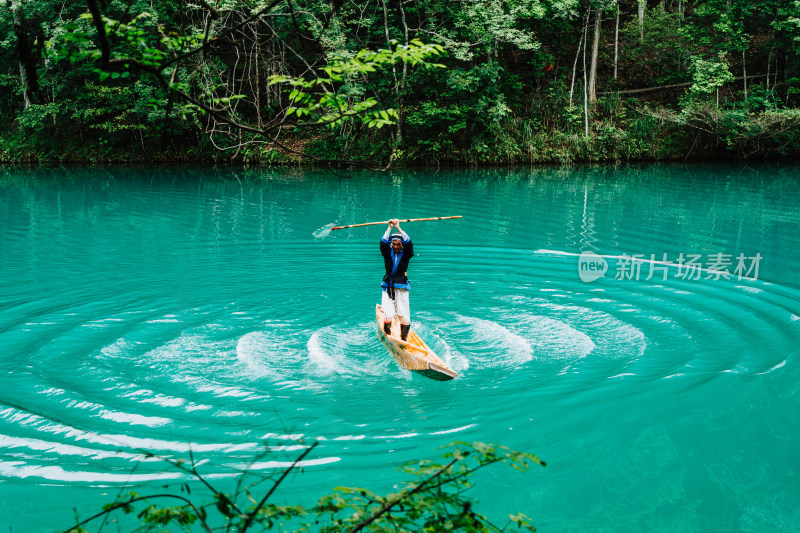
[65,441,545,533]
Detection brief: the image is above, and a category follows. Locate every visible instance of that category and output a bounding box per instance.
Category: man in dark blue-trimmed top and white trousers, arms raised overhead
[381,218,414,340]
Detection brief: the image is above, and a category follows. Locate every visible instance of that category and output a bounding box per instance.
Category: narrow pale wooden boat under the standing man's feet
[375,304,458,381]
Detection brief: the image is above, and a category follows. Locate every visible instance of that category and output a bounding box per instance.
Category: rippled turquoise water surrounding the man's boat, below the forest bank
[0,166,800,532]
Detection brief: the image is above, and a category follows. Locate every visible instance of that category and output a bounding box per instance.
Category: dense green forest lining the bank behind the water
[0,0,800,168]
